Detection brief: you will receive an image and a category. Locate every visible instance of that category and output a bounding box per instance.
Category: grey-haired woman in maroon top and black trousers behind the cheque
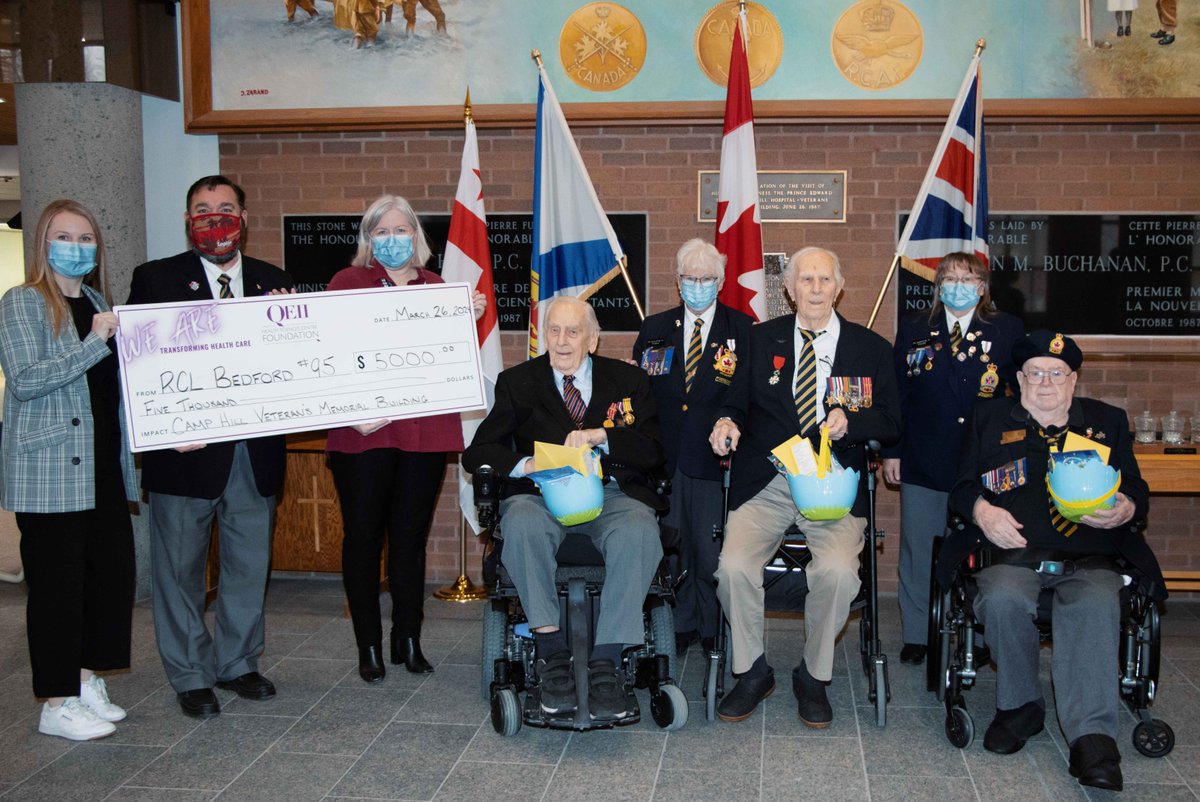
[325,196,484,682]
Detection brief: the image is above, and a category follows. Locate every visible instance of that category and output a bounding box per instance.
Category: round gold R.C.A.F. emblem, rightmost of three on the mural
[829,0,924,91]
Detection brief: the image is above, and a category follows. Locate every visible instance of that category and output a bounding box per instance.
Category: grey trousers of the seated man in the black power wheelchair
[500,481,662,645]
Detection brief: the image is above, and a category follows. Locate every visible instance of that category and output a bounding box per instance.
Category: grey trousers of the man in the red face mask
[150,443,275,693]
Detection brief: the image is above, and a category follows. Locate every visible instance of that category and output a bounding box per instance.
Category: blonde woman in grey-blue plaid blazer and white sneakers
[0,201,137,741]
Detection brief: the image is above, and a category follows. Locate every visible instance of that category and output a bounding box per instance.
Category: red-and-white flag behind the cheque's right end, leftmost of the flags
[442,112,504,534]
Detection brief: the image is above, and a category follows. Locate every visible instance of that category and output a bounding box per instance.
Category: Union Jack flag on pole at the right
[896,53,988,281]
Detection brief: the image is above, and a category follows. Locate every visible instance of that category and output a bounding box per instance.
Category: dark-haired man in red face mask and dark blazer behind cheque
[128,175,293,718]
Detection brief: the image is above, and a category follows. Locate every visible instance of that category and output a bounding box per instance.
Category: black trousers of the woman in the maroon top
[329,448,446,648]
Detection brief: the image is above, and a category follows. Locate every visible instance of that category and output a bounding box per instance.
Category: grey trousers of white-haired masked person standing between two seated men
[662,469,724,638]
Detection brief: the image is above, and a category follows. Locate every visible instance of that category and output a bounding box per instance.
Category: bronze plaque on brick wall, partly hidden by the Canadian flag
[696,169,846,223]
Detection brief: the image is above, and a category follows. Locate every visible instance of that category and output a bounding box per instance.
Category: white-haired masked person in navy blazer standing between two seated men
[634,239,754,654]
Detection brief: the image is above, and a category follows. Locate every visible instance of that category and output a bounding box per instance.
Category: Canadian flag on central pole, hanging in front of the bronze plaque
[716,12,767,323]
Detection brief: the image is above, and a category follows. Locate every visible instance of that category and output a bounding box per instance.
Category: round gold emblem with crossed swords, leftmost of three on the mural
[558,2,646,92]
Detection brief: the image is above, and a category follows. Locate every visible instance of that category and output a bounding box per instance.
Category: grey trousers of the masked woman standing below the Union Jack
[900,484,950,644]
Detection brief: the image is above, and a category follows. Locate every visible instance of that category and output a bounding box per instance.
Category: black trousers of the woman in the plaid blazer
[17,471,137,696]
